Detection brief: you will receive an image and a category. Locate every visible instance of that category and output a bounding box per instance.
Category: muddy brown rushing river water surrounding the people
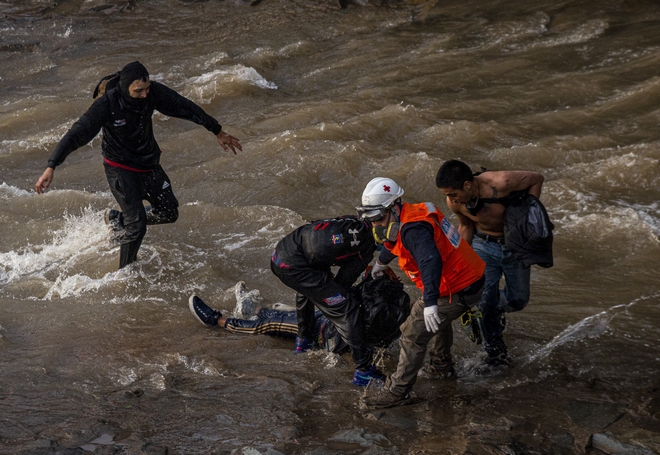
[0,0,660,455]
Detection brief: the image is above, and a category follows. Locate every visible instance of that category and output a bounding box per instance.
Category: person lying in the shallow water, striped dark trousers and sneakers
[188,271,410,364]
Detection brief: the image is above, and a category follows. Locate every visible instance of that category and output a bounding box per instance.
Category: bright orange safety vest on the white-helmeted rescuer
[385,202,486,297]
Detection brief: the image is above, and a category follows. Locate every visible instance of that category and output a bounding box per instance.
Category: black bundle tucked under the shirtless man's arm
[504,191,555,268]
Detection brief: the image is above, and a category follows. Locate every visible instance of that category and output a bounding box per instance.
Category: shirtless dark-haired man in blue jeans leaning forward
[435,160,543,366]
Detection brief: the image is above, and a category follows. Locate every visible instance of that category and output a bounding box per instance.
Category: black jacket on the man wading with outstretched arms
[48,81,222,170]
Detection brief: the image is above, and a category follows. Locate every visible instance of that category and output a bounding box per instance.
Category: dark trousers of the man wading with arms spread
[104,164,179,268]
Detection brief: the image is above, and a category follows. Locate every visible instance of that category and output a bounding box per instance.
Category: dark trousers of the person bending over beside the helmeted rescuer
[270,261,373,371]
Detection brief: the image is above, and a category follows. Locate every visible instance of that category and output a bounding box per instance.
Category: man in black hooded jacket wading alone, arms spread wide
[35,61,243,268]
